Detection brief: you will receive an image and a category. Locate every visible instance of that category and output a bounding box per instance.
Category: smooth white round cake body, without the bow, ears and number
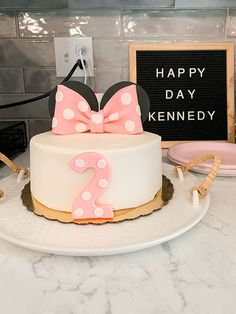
[30,132,162,212]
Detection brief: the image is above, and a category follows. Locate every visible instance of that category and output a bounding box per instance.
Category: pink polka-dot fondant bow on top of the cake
[52,85,143,134]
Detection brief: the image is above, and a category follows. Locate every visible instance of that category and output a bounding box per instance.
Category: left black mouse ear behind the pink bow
[48,81,98,117]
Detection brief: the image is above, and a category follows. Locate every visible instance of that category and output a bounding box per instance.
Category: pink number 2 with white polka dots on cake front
[69,153,114,219]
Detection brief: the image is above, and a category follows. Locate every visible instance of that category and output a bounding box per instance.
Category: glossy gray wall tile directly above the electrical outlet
[18,10,121,37]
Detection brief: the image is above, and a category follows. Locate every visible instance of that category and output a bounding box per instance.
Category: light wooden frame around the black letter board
[129,43,235,148]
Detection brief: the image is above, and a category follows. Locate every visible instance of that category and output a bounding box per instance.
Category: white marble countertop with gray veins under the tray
[0,152,236,314]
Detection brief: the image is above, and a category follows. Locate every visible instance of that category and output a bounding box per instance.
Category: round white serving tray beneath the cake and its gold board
[0,164,210,256]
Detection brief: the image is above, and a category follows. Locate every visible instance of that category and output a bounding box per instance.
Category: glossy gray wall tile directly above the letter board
[124,10,226,38]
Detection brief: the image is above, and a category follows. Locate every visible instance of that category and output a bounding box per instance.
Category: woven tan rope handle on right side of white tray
[174,153,221,197]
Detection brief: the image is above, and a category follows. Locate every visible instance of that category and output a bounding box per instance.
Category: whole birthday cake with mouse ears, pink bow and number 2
[30,82,166,220]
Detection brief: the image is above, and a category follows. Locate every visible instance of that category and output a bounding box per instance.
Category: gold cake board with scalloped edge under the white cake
[21,176,174,225]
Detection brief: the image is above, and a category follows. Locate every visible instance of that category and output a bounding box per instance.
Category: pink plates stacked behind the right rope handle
[168,142,236,176]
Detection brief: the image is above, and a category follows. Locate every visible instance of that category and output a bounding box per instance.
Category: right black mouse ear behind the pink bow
[100,81,150,123]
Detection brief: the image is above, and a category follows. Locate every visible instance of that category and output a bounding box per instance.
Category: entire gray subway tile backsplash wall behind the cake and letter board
[0,0,236,136]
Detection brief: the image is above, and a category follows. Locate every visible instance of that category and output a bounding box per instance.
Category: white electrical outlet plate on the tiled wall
[54,37,94,77]
